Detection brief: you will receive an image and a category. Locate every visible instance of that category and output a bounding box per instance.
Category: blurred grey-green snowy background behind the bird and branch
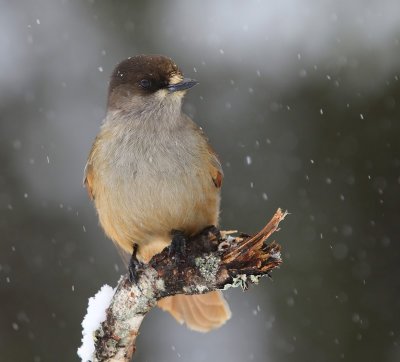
[0,0,400,362]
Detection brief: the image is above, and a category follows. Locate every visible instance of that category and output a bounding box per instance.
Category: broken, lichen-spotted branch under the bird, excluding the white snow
[93,209,287,362]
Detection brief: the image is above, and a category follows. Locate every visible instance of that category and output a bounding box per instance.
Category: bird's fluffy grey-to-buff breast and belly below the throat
[86,114,220,260]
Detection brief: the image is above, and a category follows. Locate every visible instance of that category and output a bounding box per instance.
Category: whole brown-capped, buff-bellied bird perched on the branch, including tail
[84,55,231,332]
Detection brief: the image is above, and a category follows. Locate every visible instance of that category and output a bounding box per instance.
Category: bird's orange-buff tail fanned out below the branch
[158,291,231,332]
